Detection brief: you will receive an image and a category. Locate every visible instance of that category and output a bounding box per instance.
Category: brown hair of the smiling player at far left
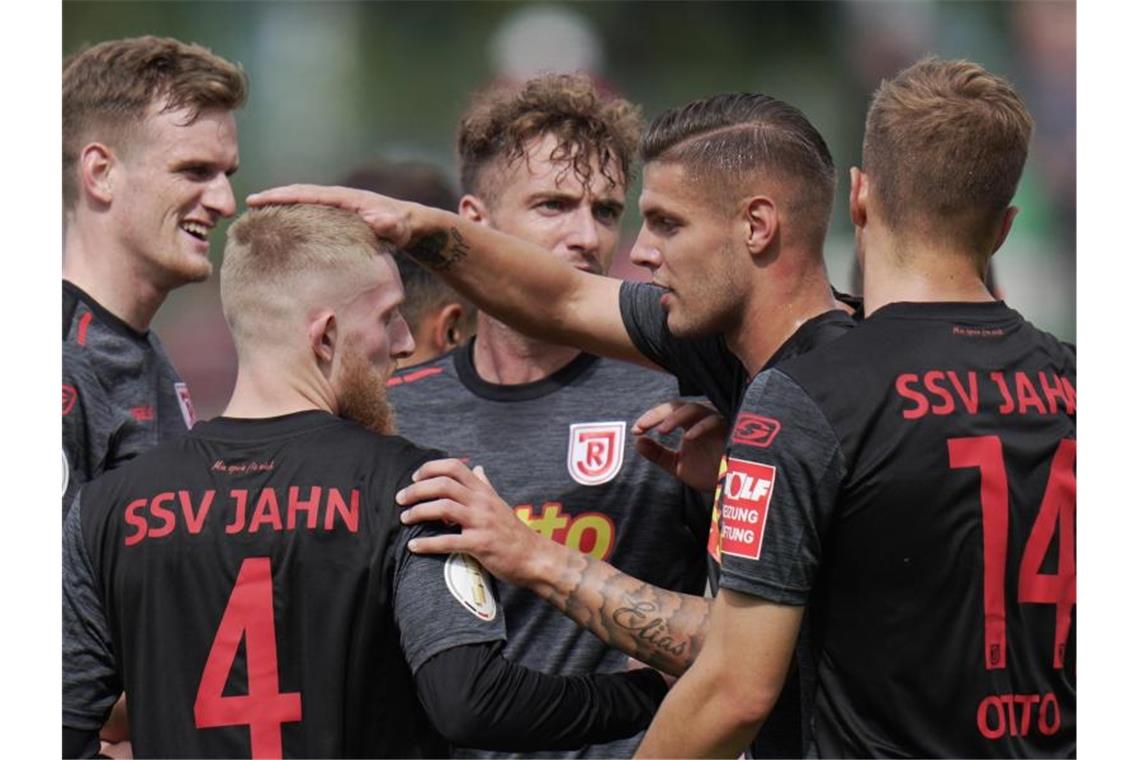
[63,36,249,207]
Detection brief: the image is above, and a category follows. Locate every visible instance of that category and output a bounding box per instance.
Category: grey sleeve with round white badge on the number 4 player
[393,523,506,673]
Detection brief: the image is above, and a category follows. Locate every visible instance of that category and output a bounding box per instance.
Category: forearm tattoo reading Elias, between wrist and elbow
[543,554,713,676]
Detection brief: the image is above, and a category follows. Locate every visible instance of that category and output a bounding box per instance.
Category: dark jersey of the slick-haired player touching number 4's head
[619,283,855,758]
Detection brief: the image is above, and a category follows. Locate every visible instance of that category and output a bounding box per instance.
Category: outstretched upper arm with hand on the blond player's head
[247,185,659,369]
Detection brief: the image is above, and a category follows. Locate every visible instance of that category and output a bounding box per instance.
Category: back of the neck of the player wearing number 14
[863,235,994,317]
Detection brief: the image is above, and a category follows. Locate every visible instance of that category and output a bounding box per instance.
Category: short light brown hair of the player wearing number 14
[863,58,1033,253]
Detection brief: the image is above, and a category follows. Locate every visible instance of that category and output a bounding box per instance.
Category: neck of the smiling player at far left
[64,216,169,333]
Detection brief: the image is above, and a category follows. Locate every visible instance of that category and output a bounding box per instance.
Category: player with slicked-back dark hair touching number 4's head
[250,84,854,757]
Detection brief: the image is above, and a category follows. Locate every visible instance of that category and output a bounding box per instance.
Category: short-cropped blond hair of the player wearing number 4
[221,205,388,351]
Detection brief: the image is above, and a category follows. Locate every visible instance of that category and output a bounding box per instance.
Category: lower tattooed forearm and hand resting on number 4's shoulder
[397,459,713,676]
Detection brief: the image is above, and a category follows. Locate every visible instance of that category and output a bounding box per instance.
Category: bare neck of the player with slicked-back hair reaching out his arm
[725,264,839,376]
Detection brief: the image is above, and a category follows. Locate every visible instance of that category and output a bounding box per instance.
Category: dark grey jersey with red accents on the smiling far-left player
[63,280,195,516]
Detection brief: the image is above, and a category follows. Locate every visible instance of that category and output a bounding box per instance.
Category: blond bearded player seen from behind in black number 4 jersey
[63,206,666,758]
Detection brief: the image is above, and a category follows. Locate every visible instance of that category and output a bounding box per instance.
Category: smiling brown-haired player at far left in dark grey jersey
[63,36,247,514]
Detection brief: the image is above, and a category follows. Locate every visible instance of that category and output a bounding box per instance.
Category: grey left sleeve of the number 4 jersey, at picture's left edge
[63,498,123,730]
